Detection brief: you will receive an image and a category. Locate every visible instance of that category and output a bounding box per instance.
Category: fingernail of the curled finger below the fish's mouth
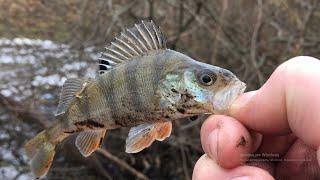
[207,129,219,163]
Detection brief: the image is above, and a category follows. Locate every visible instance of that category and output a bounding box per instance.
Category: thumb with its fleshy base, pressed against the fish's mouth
[230,56,320,148]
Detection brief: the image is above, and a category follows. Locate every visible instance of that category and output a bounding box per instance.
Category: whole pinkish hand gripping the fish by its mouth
[192,56,320,180]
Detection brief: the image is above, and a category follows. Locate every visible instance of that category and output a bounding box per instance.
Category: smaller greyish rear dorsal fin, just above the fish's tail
[55,78,86,116]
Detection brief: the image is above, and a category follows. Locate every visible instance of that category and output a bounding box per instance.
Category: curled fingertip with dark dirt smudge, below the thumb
[201,115,254,168]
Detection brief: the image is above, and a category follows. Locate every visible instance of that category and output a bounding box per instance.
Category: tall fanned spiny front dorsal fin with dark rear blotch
[99,21,166,74]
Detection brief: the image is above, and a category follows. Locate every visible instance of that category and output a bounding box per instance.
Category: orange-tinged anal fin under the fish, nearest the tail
[75,129,106,157]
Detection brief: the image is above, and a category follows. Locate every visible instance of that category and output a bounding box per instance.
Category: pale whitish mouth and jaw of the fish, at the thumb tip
[212,80,246,114]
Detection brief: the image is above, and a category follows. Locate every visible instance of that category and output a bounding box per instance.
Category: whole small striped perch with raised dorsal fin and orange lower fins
[24,21,246,178]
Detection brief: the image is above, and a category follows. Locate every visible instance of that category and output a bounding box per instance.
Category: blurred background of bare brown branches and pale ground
[0,0,320,180]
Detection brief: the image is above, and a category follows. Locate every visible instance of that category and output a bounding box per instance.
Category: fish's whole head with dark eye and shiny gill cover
[162,51,246,116]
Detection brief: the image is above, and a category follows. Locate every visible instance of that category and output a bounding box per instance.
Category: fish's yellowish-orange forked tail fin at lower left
[24,121,68,178]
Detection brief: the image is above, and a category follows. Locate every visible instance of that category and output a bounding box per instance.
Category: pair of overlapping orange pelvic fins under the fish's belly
[126,122,172,153]
